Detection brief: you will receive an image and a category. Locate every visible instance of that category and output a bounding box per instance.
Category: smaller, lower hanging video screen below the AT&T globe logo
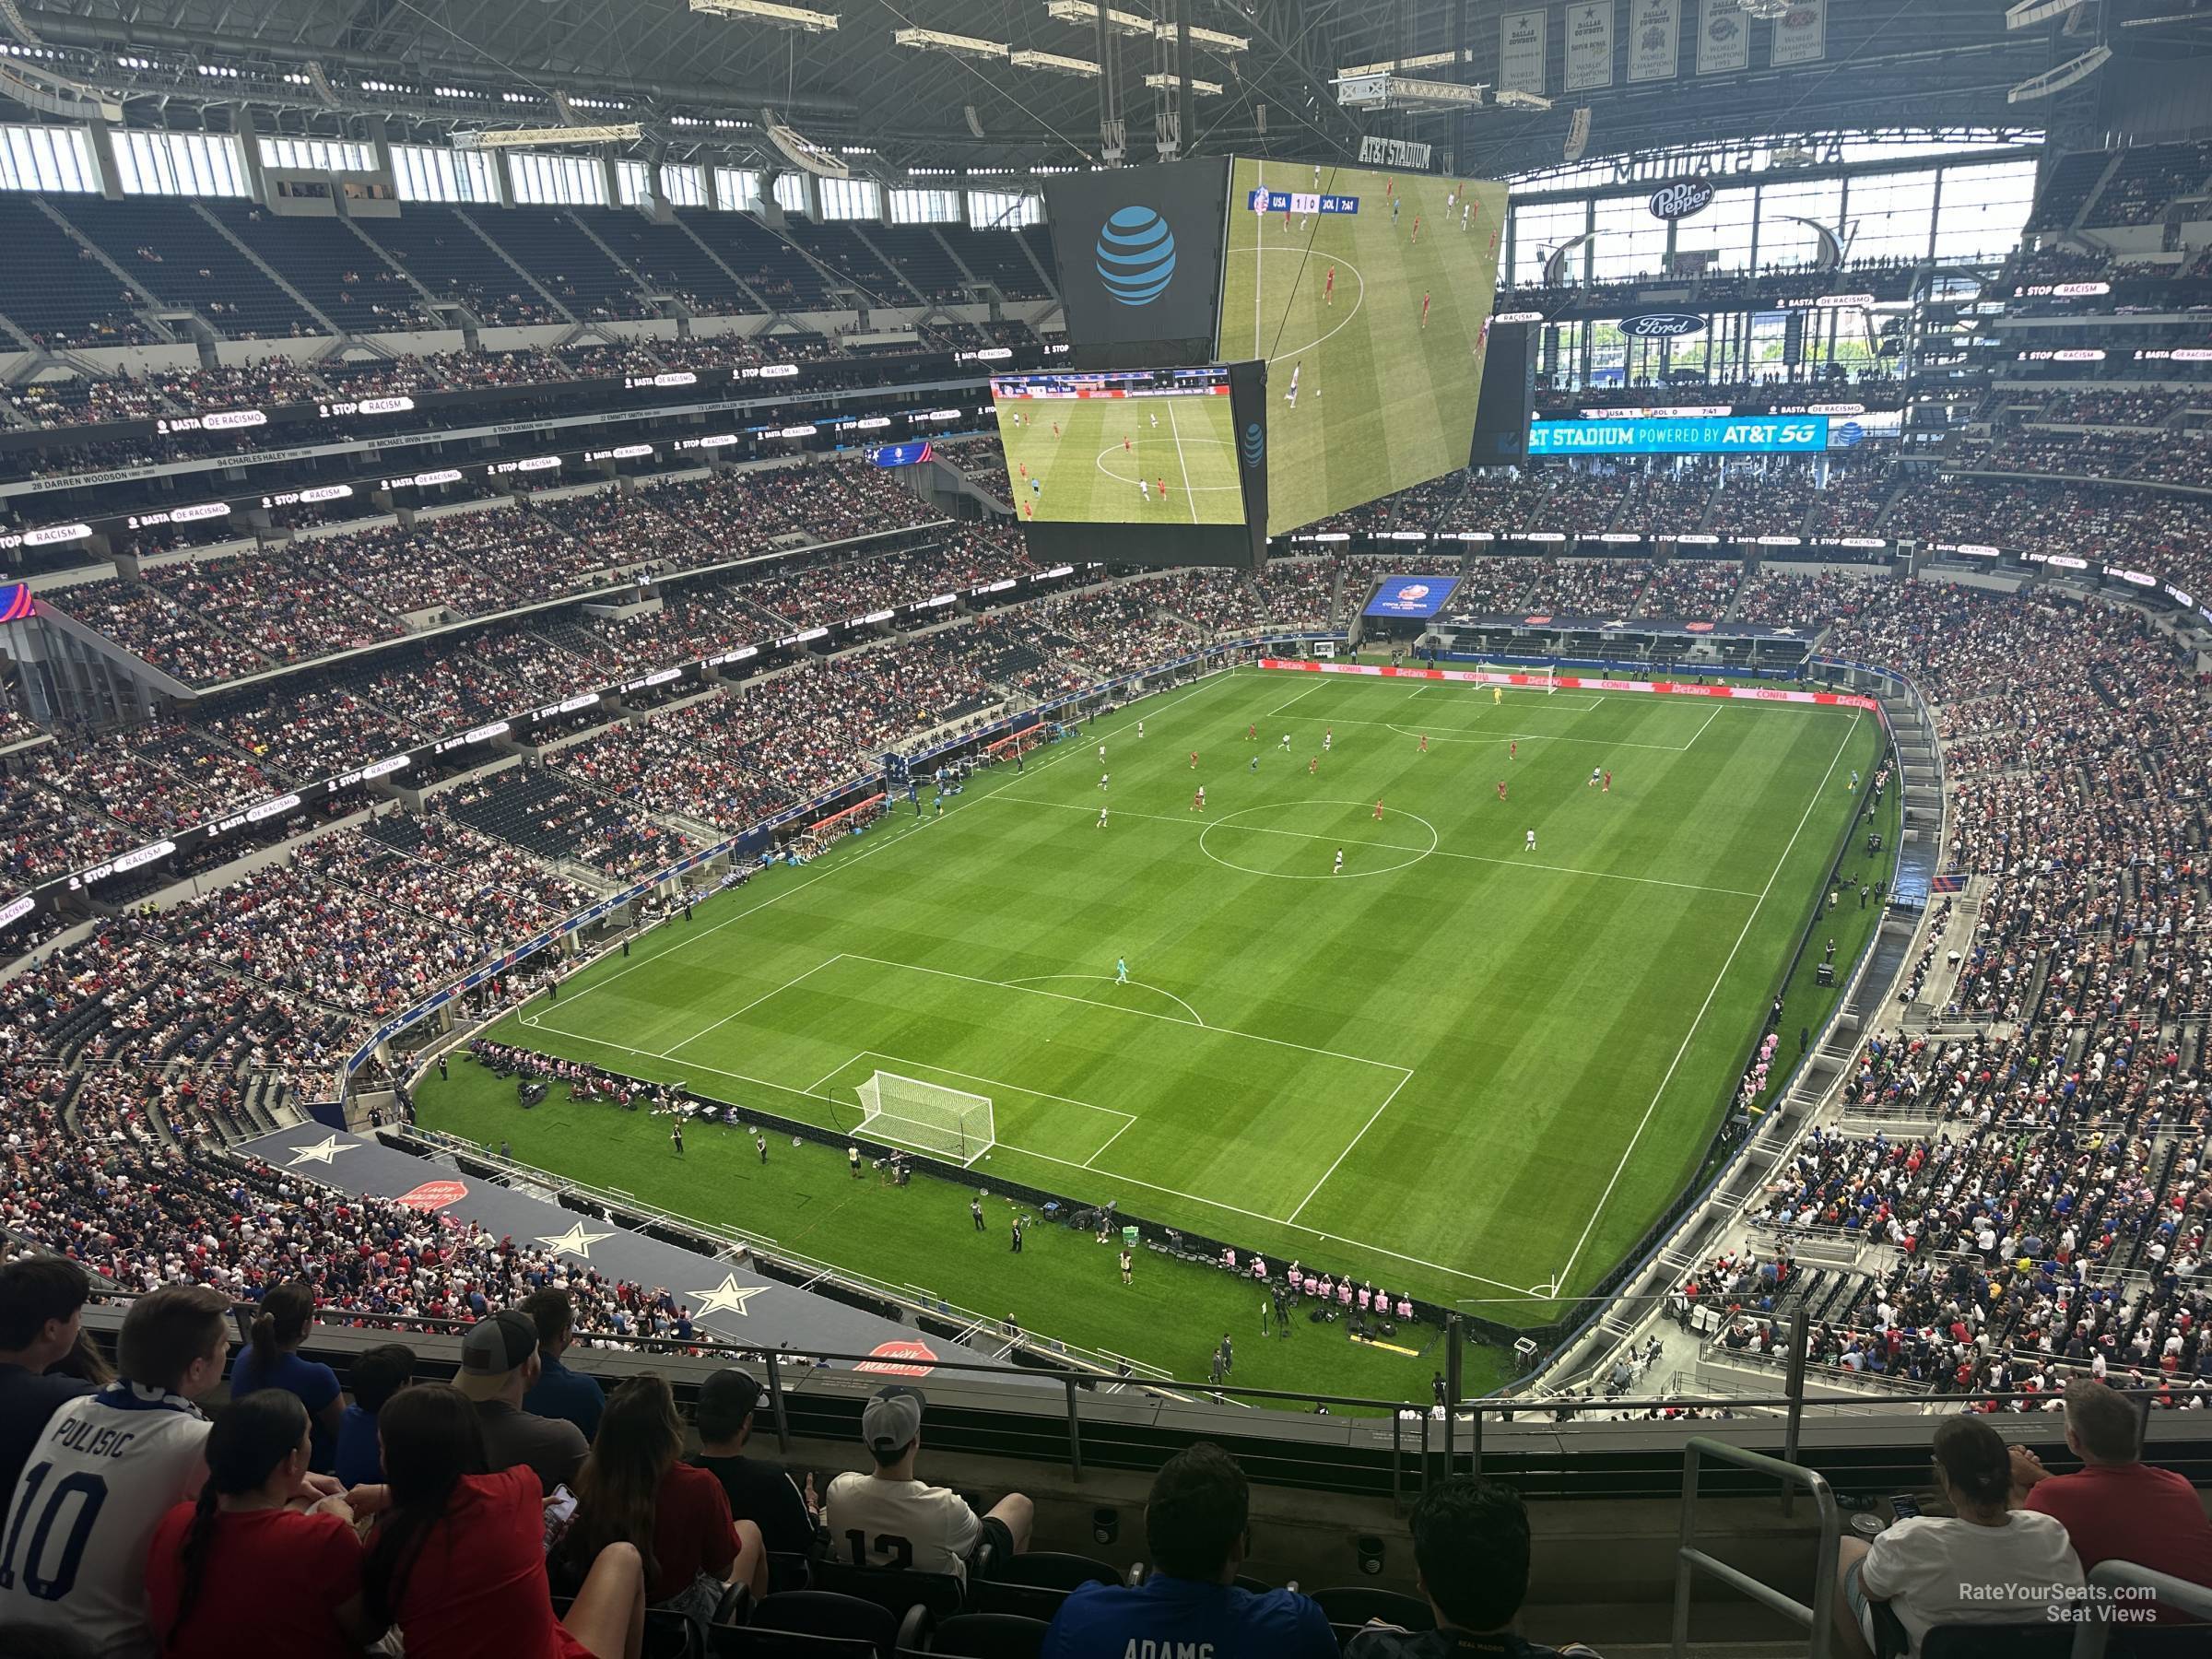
[991,367,1245,524]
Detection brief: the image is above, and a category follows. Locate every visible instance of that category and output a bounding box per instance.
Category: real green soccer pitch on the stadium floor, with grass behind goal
[420,670,1880,1398]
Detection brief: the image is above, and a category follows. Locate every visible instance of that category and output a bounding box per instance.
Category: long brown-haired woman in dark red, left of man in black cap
[559,1371,768,1617]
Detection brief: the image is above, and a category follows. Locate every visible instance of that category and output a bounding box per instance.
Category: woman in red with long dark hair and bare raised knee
[347,1382,646,1659]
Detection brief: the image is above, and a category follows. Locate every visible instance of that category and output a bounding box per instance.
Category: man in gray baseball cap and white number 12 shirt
[823,1387,1038,1582]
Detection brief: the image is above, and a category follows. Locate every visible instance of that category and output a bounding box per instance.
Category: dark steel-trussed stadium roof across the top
[0,0,2212,179]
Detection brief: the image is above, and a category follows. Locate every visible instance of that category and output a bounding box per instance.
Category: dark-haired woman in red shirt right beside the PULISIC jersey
[146,1389,376,1659]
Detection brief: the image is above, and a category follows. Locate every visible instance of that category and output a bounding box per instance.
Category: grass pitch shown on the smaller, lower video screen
[997,396,1243,524]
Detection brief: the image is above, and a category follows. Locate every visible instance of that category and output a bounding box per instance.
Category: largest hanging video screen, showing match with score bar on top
[1217,157,1506,535]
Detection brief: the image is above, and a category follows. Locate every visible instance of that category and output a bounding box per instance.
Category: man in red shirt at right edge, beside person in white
[2013,1378,2212,1621]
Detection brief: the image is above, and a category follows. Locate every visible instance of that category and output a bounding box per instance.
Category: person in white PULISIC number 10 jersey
[0,1285,273,1659]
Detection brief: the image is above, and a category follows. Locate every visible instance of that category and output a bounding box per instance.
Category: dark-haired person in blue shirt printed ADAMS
[1041,1442,1336,1659]
